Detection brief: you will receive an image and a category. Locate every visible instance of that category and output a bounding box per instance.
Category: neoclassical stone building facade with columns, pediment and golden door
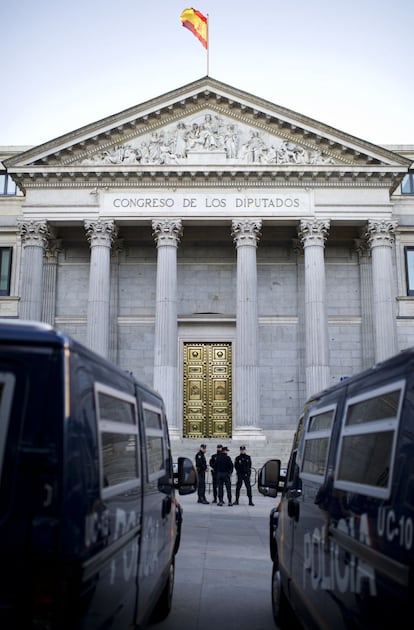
[0,77,414,460]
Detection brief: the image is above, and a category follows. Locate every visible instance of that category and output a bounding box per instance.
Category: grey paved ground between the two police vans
[151,487,277,630]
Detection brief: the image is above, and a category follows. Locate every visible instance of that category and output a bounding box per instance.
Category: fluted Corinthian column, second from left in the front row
[84,219,118,358]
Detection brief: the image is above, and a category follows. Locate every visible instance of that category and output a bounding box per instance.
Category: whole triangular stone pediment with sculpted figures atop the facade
[6,77,409,188]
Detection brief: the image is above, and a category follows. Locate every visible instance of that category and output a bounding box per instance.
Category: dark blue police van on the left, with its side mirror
[0,320,196,630]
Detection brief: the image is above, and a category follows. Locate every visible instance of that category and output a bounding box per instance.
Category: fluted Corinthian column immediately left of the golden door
[152,219,183,437]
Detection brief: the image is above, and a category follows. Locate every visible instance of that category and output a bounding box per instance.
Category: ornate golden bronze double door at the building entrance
[183,343,232,438]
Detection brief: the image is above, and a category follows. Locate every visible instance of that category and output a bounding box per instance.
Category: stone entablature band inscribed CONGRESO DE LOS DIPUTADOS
[12,186,394,228]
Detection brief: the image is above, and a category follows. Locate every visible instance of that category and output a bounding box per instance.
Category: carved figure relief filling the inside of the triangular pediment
[81,113,341,166]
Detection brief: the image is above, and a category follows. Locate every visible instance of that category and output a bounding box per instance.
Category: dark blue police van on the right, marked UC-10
[258,349,414,630]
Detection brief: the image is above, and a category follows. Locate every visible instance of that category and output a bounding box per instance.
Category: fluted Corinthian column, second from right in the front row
[298,219,330,396]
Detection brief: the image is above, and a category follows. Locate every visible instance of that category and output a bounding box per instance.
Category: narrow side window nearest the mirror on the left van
[143,403,167,481]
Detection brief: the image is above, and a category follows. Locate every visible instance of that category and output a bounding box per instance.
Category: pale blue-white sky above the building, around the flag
[0,0,414,146]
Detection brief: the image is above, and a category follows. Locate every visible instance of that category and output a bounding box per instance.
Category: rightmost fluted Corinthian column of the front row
[366,220,398,362]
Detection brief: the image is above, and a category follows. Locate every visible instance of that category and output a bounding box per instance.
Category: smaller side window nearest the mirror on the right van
[301,406,336,478]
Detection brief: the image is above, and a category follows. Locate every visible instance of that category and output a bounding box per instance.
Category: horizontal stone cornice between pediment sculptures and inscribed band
[14,165,406,192]
